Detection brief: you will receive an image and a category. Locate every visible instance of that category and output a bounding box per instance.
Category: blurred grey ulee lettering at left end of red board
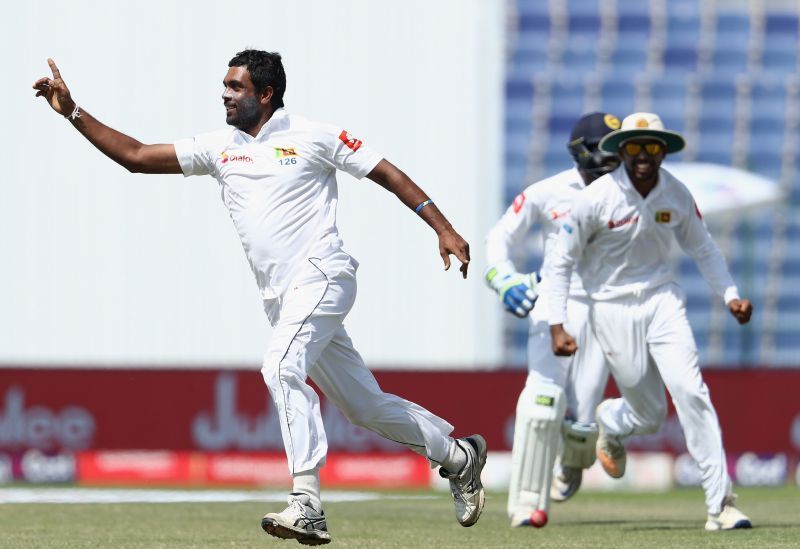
[0,387,95,450]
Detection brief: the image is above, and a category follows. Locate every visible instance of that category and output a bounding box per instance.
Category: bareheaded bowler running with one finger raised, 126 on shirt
[33,50,486,545]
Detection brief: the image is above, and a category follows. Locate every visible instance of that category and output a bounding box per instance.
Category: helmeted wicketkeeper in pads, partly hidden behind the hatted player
[486,112,620,527]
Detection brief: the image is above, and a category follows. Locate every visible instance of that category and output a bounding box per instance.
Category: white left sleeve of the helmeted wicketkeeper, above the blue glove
[486,185,541,265]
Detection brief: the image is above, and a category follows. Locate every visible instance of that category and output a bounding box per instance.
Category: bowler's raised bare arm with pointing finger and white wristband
[33,59,181,173]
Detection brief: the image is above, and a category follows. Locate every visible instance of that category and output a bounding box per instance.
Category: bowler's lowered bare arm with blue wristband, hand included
[367,159,469,278]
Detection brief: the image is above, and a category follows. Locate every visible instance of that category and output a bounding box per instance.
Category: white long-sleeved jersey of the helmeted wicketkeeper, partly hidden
[486,168,586,296]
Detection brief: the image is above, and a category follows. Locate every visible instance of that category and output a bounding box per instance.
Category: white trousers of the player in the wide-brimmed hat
[591,283,732,513]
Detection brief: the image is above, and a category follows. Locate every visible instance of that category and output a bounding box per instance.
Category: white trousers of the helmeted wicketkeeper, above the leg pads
[525,296,608,424]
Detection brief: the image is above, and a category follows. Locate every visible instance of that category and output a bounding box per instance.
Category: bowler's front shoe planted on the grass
[261,494,331,545]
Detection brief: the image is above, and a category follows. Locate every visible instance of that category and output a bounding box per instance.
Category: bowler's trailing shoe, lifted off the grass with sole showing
[439,435,486,526]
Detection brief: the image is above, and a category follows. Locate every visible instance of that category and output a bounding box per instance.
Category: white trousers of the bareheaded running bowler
[261,251,453,474]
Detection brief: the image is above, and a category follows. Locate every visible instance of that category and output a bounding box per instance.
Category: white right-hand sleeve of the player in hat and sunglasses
[675,193,739,304]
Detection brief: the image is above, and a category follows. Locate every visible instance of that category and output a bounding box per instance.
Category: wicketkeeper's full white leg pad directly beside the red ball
[508,384,567,520]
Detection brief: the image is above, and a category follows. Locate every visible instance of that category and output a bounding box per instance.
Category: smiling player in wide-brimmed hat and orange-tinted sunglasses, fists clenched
[547,113,753,530]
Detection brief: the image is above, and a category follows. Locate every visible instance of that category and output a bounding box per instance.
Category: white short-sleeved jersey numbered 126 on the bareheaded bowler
[175,109,382,299]
